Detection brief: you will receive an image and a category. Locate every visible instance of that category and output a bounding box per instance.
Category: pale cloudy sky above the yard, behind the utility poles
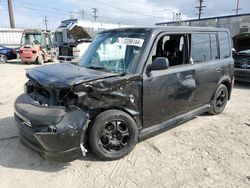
[0,0,250,29]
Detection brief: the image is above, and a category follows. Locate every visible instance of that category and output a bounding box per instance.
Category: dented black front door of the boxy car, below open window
[143,33,196,128]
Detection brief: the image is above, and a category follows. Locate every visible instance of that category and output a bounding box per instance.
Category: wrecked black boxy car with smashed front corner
[14,27,234,161]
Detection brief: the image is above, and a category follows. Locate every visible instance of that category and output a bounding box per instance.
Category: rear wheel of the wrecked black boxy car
[209,84,228,115]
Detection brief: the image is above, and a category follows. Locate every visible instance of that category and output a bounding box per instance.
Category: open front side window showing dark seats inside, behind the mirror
[152,34,189,66]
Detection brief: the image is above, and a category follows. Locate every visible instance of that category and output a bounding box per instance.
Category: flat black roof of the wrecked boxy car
[101,26,228,33]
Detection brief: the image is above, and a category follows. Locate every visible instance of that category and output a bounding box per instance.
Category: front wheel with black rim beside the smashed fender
[88,110,138,160]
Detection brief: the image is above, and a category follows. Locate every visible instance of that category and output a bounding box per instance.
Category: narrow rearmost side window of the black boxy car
[219,32,231,59]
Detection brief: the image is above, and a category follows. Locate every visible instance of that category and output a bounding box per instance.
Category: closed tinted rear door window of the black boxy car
[192,33,211,63]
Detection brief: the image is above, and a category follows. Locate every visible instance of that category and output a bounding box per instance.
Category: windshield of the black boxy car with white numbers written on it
[79,31,146,73]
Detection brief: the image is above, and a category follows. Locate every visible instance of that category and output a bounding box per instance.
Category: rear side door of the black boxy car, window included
[191,32,222,108]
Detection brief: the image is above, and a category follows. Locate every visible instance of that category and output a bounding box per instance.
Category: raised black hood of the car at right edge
[233,33,250,52]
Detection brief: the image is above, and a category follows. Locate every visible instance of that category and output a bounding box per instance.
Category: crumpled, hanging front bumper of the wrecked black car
[14,94,89,162]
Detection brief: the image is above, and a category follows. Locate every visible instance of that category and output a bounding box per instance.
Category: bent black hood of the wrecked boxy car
[26,63,119,88]
